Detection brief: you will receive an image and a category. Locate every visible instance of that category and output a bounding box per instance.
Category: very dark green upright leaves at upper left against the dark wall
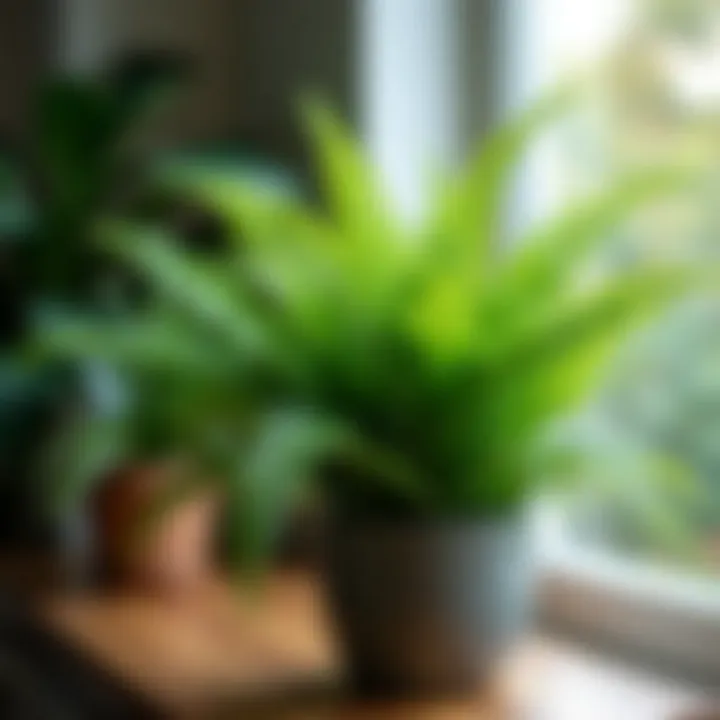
[21,54,184,301]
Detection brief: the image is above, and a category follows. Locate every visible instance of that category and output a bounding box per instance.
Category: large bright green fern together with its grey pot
[46,90,690,694]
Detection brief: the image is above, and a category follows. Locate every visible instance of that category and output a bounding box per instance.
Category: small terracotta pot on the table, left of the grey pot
[96,462,217,594]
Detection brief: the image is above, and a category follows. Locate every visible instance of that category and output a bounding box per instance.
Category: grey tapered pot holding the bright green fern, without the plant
[328,518,532,696]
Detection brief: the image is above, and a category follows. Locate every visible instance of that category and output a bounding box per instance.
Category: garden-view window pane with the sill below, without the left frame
[537,0,720,677]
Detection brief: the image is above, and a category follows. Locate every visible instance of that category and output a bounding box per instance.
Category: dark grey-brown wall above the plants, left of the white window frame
[55,0,357,156]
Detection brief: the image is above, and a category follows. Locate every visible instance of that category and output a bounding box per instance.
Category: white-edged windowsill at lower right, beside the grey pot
[540,542,720,687]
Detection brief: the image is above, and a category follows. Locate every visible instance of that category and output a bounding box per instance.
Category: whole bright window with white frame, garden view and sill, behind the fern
[361,0,720,677]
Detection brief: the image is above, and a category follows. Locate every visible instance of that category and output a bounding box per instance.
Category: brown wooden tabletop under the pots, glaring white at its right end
[42,575,720,720]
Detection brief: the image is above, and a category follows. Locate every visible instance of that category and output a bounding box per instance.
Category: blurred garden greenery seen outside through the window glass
[562,0,720,576]
